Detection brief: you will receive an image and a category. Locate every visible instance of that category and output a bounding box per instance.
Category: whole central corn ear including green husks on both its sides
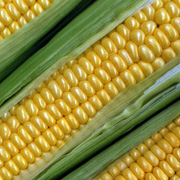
[0,0,180,179]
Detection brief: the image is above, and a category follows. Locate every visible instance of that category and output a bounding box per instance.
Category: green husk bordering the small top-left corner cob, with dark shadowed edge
[0,0,87,81]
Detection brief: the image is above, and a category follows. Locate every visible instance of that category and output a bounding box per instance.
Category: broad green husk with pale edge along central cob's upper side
[0,0,150,108]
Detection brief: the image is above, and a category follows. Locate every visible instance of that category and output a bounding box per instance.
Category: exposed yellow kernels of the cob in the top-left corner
[0,0,52,41]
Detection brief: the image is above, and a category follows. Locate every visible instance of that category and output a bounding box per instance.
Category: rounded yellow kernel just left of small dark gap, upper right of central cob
[141,21,157,36]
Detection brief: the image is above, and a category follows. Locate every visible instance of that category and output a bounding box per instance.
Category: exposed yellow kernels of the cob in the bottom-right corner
[98,117,180,180]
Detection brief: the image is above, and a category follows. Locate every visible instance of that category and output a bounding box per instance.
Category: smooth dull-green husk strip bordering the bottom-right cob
[62,100,180,180]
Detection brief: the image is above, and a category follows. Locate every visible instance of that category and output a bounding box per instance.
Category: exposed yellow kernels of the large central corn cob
[0,1,180,179]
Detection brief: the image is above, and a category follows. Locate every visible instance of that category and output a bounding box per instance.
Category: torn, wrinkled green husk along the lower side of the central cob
[34,64,180,180]
